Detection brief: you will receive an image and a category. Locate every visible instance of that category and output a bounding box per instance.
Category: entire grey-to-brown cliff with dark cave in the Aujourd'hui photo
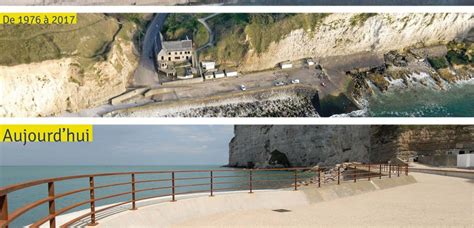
[229,125,474,168]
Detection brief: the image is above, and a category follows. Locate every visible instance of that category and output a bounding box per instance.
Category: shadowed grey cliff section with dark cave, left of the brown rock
[229,125,370,168]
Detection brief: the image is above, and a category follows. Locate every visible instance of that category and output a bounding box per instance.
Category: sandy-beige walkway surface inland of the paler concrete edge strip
[175,173,474,227]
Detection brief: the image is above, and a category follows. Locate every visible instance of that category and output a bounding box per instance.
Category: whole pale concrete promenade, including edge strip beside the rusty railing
[51,173,474,227]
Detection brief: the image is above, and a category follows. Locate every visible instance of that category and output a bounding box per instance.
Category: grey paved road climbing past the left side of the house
[133,13,167,87]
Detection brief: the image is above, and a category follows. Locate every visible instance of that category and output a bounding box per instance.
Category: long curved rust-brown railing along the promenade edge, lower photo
[0,164,408,227]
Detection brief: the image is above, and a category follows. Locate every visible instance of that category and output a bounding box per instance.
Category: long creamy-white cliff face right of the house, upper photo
[240,13,474,71]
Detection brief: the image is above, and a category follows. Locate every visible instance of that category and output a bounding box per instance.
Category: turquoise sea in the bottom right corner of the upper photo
[368,84,474,117]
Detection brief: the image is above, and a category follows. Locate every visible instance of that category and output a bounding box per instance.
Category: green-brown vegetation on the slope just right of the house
[197,13,329,66]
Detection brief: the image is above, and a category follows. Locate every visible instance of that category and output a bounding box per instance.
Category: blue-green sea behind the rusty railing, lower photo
[0,165,304,227]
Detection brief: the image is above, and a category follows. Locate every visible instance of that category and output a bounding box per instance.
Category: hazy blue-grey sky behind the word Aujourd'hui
[0,125,234,166]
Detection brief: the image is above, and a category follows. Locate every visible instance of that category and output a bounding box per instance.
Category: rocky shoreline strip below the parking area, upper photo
[105,85,319,117]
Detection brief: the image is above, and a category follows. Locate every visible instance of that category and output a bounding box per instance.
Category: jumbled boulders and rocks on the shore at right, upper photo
[347,41,474,107]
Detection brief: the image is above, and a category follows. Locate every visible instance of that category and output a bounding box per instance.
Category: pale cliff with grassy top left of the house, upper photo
[0,14,138,117]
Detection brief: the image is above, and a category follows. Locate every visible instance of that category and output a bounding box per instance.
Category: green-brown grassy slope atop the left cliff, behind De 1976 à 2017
[0,14,143,65]
